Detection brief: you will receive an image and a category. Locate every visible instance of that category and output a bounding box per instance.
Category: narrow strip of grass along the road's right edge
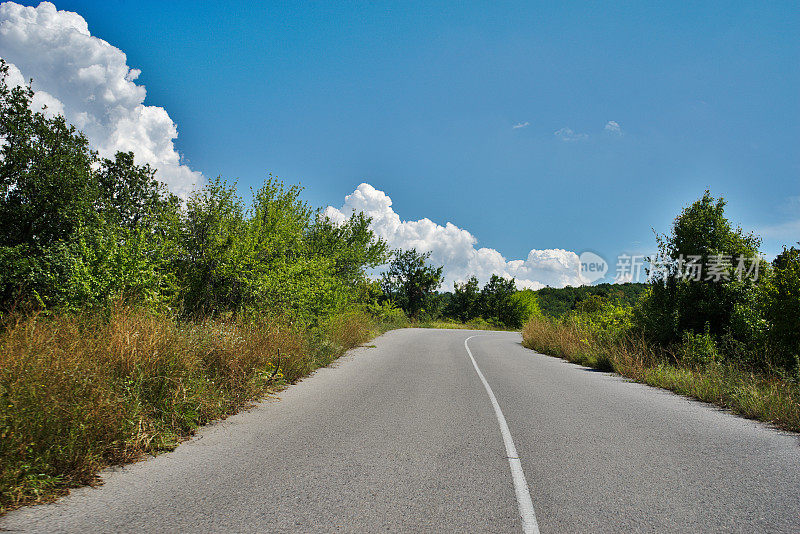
[522,319,800,432]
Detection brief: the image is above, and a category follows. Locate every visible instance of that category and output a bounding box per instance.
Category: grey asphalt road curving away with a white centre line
[0,329,800,533]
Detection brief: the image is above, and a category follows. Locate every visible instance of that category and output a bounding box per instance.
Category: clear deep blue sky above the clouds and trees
[6,1,800,286]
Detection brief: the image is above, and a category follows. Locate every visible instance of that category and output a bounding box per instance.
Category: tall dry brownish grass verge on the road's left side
[0,308,403,514]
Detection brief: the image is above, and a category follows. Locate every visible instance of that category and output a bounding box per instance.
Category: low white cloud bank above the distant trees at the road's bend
[324,184,581,290]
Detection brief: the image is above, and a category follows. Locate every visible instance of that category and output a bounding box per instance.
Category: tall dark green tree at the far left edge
[0,59,97,308]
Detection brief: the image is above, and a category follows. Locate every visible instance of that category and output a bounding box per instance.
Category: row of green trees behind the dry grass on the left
[0,59,400,320]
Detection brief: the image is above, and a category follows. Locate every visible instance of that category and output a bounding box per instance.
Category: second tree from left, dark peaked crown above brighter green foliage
[70,152,181,306]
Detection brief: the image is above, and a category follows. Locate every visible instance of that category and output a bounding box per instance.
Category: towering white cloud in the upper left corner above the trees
[0,2,202,196]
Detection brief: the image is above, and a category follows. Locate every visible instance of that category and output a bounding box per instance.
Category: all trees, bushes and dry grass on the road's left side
[0,59,535,514]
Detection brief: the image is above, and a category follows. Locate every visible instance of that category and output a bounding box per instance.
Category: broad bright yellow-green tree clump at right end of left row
[179,177,386,325]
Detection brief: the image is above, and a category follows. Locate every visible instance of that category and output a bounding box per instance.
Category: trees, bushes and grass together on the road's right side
[523,192,800,432]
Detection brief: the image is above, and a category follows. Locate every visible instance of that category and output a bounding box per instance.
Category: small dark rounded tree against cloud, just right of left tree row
[381,249,443,318]
